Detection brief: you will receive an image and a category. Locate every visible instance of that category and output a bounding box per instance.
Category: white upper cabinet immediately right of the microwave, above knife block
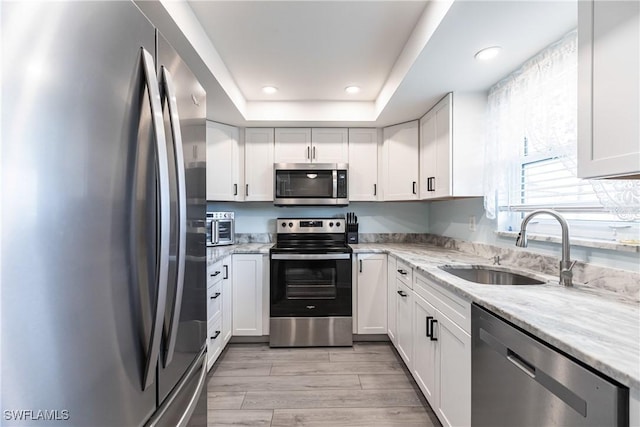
[349,129,378,202]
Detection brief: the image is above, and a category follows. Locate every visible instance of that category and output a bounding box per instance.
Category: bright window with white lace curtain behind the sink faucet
[485,31,640,241]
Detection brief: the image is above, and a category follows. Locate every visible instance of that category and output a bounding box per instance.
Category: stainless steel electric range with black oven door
[269,218,353,347]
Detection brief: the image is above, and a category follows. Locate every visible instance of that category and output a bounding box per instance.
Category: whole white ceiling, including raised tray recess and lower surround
[137,0,577,126]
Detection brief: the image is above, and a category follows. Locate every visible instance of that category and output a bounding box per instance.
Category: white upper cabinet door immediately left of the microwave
[244,128,274,202]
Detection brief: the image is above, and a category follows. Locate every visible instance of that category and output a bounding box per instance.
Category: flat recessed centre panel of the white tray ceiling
[189,1,426,101]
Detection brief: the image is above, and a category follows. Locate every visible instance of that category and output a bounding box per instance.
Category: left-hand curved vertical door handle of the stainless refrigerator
[141,48,171,390]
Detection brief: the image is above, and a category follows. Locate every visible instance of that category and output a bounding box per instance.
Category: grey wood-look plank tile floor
[207,343,440,427]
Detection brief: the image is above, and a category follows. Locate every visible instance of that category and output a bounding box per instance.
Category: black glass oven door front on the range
[271,259,351,317]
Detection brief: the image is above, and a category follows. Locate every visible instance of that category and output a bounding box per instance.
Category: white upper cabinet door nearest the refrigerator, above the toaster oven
[207,121,243,201]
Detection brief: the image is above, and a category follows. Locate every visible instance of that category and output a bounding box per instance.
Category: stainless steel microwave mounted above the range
[273,163,349,206]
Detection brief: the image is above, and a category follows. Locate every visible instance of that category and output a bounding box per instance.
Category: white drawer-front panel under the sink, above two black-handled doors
[413,273,471,334]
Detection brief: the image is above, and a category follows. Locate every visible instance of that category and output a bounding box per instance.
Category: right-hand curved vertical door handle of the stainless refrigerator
[161,66,187,368]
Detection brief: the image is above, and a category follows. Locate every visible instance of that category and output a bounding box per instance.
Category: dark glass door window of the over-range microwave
[276,170,333,199]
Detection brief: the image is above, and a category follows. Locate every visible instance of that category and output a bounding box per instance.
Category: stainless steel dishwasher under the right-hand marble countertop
[471,305,629,427]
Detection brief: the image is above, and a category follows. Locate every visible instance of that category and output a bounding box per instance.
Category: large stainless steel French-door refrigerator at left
[0,1,207,427]
